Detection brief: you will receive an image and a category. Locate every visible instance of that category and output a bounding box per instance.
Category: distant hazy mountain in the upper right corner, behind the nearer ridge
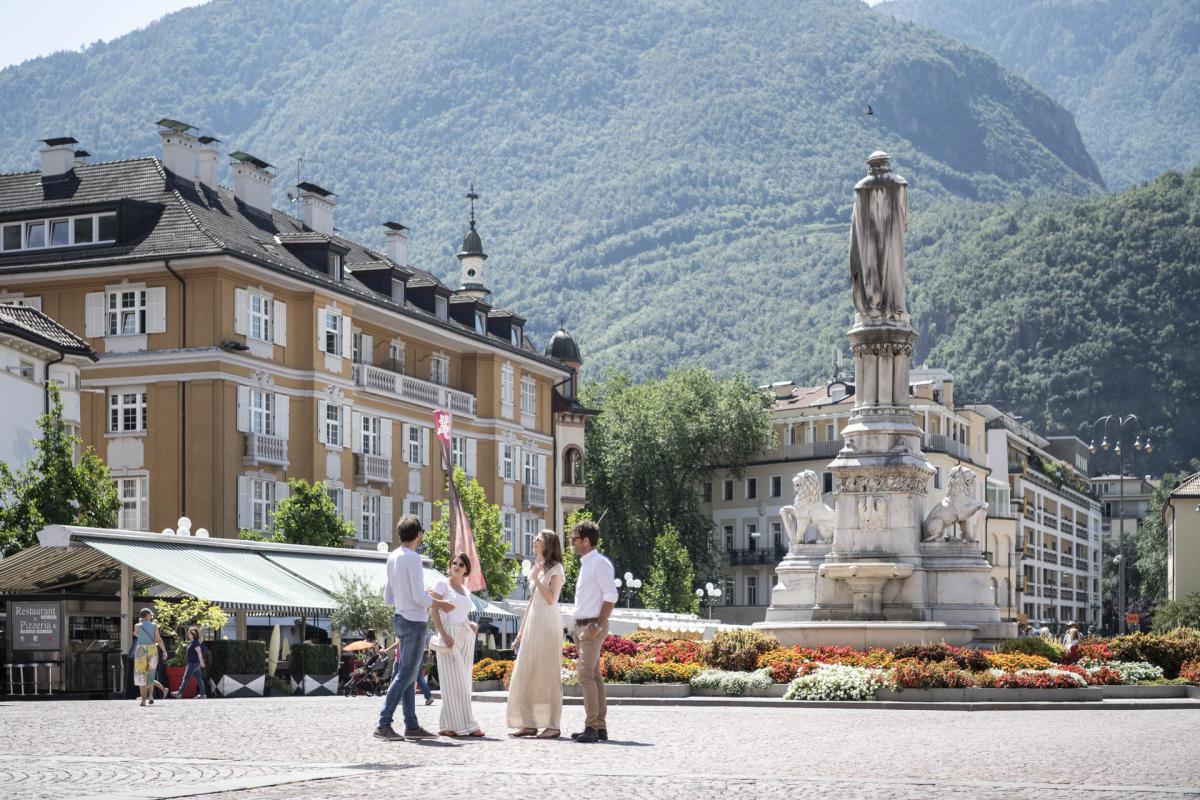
[876,0,1200,188]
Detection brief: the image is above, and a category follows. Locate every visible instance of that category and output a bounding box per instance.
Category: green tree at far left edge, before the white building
[0,383,121,554]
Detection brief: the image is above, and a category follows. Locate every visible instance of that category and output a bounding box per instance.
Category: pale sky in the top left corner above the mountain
[0,0,204,70]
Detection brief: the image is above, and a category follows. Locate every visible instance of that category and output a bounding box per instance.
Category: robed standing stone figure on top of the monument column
[850,150,908,319]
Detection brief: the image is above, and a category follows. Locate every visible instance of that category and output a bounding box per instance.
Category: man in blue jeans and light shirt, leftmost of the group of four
[374,515,454,741]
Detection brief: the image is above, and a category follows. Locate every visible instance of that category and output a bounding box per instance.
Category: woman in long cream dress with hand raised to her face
[508,530,566,739]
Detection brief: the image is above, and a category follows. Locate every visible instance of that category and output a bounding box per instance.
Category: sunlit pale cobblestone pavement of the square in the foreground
[0,697,1200,800]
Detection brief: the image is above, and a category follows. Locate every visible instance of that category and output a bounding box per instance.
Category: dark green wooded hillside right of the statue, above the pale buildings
[907,168,1200,475]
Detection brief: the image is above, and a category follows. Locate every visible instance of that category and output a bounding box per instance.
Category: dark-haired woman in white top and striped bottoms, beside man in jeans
[433,553,484,736]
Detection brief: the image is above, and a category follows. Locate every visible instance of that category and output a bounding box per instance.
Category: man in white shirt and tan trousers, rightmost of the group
[571,519,617,744]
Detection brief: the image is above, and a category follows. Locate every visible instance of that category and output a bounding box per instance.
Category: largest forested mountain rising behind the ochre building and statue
[0,0,1102,388]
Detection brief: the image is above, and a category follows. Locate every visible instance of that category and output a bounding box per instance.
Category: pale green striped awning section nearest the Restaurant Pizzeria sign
[79,536,335,615]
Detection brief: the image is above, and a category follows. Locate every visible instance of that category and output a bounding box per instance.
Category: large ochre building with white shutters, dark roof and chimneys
[0,120,584,552]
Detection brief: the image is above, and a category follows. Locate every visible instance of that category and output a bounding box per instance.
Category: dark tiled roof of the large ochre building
[0,157,562,367]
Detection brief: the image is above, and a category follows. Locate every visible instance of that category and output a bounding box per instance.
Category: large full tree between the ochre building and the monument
[584,368,772,576]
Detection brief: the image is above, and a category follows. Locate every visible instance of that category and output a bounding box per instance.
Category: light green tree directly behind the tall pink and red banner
[425,467,517,599]
